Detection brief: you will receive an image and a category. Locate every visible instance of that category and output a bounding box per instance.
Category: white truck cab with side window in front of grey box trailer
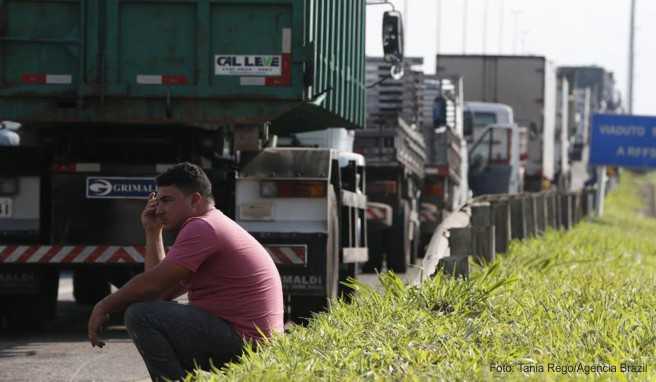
[465,102,528,196]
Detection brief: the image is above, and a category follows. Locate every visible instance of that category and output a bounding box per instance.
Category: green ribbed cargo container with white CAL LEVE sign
[0,0,365,132]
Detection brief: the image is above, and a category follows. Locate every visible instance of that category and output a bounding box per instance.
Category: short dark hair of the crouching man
[156,162,213,199]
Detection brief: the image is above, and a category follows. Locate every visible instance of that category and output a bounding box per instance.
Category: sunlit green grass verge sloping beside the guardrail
[189,173,656,381]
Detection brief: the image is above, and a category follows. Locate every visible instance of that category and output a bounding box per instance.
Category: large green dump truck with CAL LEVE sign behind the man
[0,0,402,326]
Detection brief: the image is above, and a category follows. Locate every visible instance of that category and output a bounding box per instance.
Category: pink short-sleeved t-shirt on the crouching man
[164,209,283,340]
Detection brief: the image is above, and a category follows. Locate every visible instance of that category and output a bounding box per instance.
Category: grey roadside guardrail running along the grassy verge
[409,188,599,285]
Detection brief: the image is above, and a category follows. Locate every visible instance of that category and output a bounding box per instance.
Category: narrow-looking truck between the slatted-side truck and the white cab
[419,75,469,255]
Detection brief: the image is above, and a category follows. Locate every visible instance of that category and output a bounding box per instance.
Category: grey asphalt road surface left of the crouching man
[0,274,150,382]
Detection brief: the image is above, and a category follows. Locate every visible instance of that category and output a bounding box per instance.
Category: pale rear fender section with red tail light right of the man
[235,129,368,321]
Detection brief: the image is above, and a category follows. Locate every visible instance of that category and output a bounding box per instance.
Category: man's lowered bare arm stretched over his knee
[88,262,192,347]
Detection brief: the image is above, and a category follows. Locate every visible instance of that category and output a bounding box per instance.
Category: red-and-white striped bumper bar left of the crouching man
[0,245,146,264]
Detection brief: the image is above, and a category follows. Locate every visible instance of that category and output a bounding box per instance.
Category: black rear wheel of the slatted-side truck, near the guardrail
[385,201,412,273]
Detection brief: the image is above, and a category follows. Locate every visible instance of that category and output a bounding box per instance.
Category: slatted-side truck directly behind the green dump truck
[354,57,426,273]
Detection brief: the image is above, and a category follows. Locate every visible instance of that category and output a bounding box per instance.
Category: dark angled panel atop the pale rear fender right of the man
[240,149,330,179]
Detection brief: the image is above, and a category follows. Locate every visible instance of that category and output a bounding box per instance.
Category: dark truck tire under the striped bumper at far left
[6,269,59,330]
